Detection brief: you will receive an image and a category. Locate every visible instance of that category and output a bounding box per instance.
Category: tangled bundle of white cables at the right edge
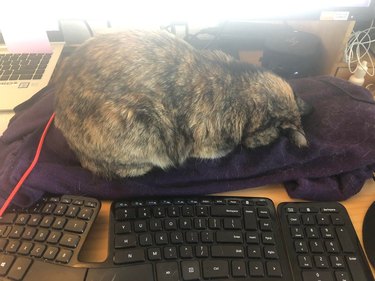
[345,20,375,76]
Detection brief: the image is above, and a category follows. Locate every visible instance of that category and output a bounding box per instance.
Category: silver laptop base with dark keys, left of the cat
[0,43,64,111]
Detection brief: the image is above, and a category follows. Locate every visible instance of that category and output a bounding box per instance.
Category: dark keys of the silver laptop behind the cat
[0,54,51,81]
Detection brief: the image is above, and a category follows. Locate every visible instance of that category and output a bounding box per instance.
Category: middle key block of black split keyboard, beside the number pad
[110,197,291,281]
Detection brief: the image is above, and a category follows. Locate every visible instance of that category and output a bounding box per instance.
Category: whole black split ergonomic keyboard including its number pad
[0,195,372,281]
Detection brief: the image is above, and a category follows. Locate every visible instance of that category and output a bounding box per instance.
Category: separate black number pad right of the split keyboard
[278,202,373,281]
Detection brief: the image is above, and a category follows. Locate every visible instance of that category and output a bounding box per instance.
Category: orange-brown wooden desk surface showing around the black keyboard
[81,177,375,276]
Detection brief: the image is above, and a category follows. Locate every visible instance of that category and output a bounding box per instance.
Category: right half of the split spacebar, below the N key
[86,264,154,281]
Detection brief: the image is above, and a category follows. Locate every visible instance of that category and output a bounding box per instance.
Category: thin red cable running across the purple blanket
[0,113,55,217]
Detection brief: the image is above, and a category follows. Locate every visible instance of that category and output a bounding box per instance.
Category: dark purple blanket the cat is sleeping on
[0,77,375,206]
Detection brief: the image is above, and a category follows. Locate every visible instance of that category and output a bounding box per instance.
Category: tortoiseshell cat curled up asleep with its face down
[52,30,307,178]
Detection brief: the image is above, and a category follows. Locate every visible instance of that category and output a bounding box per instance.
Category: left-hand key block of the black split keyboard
[0,195,100,281]
